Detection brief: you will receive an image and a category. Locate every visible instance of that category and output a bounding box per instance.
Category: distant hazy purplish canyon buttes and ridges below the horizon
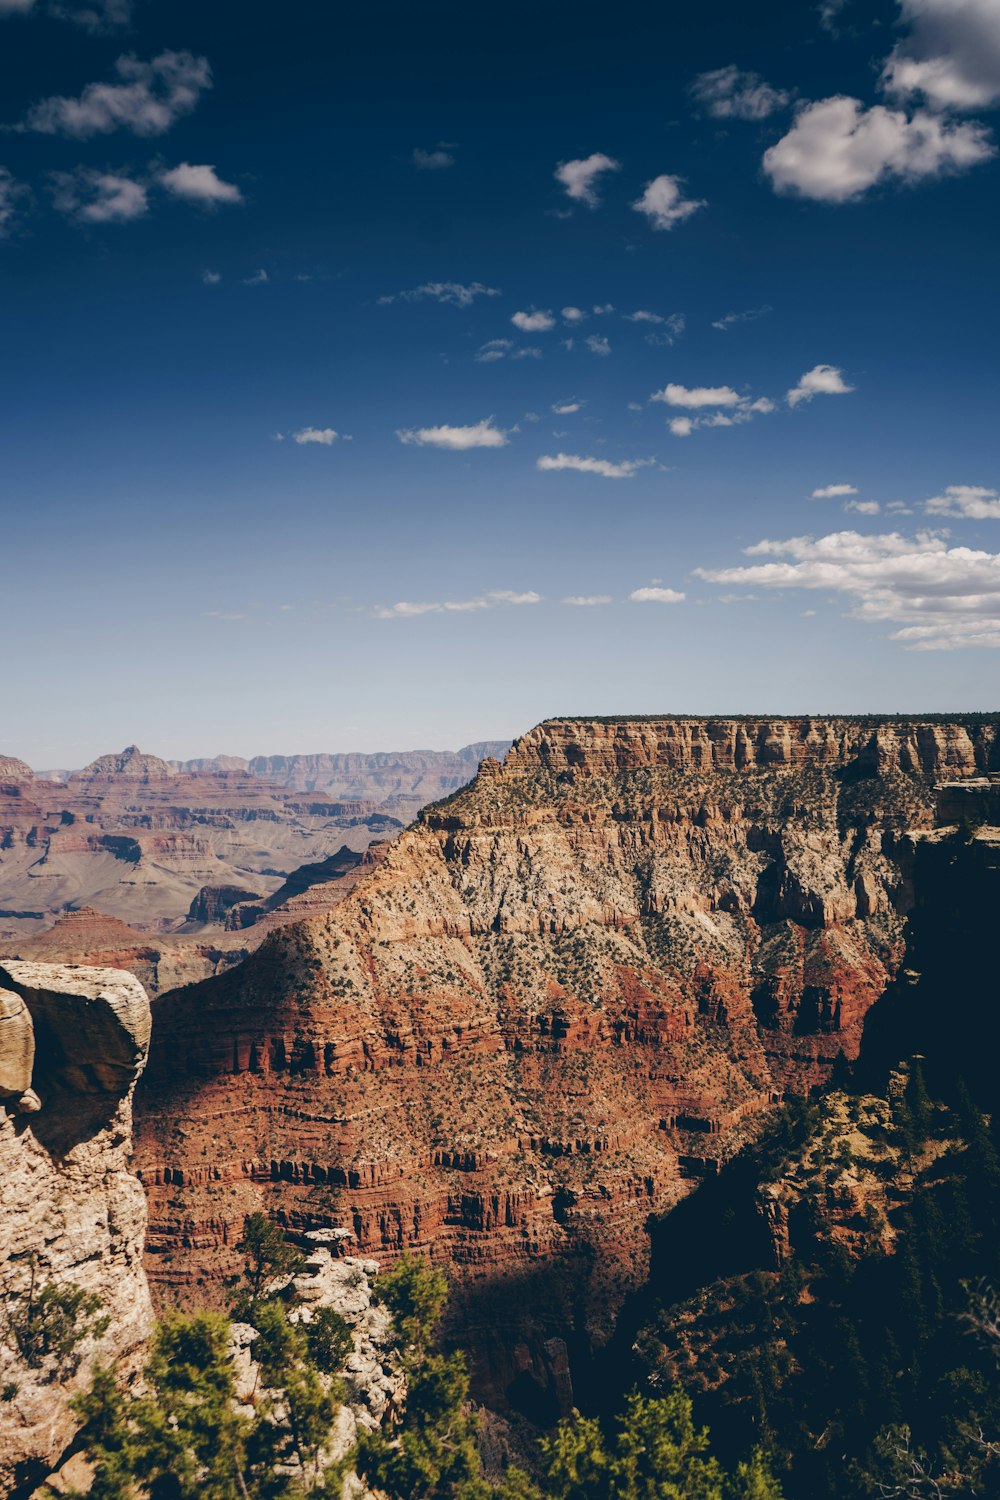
[0,746,512,989]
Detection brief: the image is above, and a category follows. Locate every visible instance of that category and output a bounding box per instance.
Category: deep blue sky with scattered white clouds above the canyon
[0,0,1000,765]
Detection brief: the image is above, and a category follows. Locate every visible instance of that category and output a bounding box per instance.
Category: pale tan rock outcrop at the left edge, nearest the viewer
[0,960,151,1497]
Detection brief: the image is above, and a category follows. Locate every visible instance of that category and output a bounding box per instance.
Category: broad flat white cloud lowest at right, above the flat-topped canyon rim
[696,531,1000,651]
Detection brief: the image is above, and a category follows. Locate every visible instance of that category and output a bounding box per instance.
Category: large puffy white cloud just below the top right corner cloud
[763,95,994,203]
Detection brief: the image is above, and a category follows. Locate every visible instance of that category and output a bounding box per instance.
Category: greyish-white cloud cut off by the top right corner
[882,0,1000,110]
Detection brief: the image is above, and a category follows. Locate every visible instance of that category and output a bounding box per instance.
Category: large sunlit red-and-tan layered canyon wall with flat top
[136,716,1000,1404]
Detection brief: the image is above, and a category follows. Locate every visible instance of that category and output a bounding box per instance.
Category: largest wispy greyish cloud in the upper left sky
[24,53,211,140]
